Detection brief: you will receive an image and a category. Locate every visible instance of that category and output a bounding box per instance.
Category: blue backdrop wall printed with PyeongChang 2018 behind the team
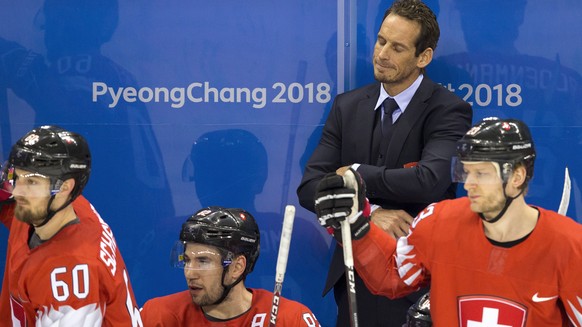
[0,0,582,326]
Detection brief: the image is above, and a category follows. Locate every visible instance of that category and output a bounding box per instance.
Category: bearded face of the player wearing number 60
[12,169,50,225]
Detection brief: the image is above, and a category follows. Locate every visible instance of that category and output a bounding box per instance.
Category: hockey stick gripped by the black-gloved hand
[341,172,361,327]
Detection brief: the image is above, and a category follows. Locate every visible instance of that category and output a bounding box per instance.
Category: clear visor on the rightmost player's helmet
[451,157,503,184]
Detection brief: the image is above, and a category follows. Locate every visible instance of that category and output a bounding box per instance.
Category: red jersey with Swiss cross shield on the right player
[354,198,582,327]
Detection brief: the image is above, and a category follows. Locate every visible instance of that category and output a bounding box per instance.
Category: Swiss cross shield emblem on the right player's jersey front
[459,295,527,327]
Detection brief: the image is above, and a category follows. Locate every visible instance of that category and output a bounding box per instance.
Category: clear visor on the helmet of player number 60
[0,163,62,197]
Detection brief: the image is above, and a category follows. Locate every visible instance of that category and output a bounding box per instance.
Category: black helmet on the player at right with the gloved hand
[453,117,536,183]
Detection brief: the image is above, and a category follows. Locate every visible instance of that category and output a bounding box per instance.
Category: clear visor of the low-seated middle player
[170,241,234,270]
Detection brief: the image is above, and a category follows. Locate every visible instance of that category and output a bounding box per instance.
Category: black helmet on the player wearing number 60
[8,125,91,201]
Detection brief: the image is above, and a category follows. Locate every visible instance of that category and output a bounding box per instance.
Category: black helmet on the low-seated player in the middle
[180,206,260,276]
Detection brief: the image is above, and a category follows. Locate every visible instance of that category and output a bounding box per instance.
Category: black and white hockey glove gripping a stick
[315,168,370,242]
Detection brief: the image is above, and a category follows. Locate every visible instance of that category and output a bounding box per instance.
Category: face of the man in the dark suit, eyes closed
[373,14,432,95]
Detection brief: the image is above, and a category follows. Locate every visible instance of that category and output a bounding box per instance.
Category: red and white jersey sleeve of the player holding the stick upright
[353,205,434,299]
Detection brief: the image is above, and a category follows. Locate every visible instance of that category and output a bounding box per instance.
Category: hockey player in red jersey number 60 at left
[0,126,142,327]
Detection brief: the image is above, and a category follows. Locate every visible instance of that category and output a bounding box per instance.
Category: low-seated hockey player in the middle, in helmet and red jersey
[142,207,320,327]
